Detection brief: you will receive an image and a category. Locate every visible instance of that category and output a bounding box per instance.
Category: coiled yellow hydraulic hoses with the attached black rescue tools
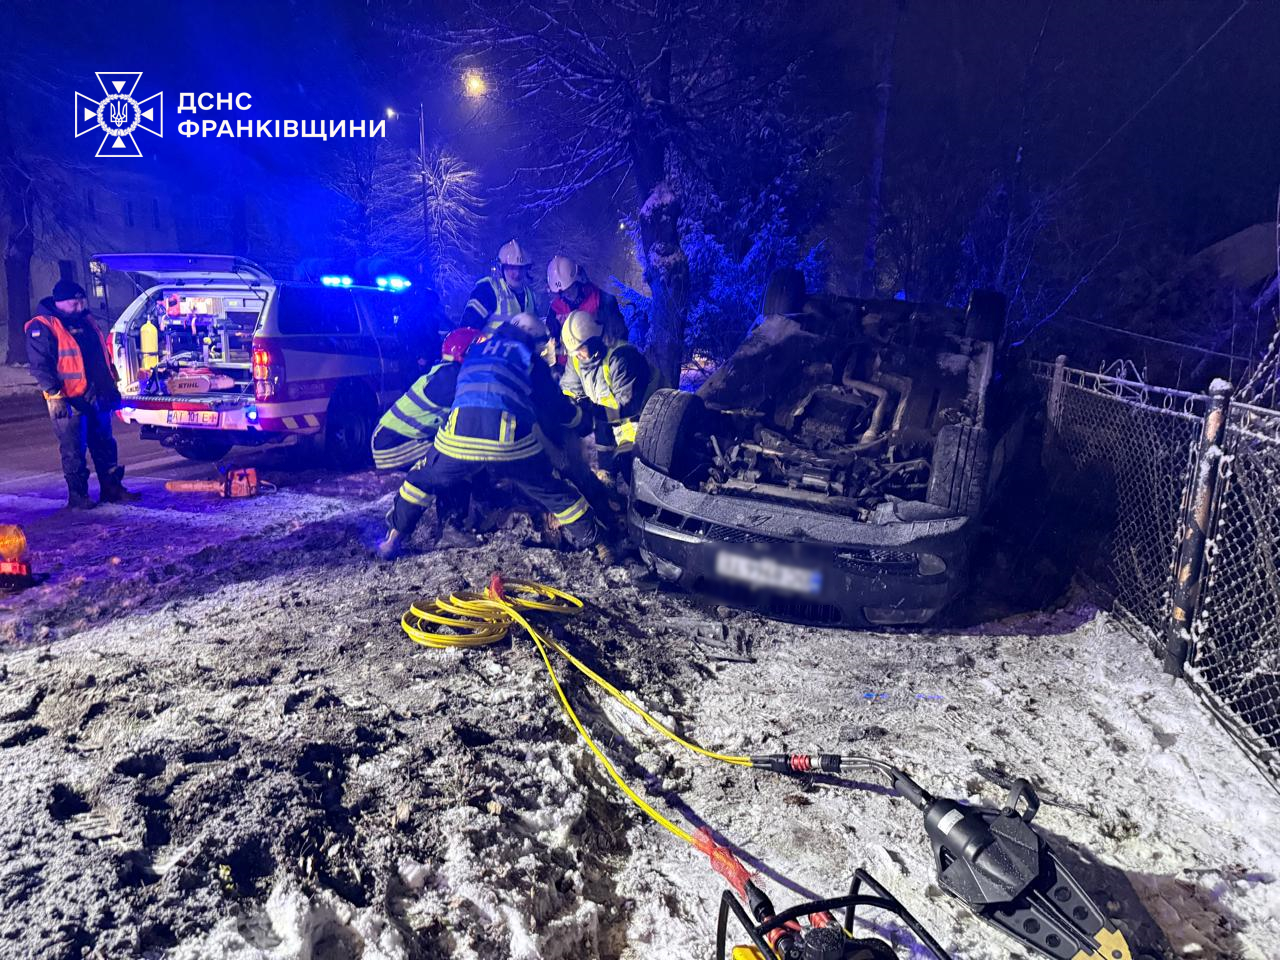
[401,583,1132,960]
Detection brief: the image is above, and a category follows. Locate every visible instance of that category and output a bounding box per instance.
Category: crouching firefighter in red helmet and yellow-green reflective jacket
[372,326,480,470]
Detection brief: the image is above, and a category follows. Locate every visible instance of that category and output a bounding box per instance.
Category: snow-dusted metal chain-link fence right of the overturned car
[1033,360,1280,785]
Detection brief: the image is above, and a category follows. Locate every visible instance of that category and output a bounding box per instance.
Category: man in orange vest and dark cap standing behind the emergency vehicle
[26,280,138,509]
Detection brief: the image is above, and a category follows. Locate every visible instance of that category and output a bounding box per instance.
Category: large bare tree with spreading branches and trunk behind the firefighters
[426,0,834,378]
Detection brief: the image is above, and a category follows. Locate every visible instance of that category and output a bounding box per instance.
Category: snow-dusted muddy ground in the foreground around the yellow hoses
[0,474,1280,960]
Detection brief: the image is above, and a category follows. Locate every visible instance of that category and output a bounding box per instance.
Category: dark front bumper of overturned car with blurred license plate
[627,460,977,627]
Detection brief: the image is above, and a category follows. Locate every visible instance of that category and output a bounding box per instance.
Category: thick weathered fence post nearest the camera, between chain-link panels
[1165,380,1233,677]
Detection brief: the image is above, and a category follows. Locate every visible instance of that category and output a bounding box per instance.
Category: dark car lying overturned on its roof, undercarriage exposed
[627,271,1029,626]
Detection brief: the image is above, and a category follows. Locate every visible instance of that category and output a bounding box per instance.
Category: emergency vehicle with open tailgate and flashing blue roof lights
[95,253,439,467]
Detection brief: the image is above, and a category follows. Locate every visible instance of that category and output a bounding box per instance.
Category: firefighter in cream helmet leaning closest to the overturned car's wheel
[561,310,662,480]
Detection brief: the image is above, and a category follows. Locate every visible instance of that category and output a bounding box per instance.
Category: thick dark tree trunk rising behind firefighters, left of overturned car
[631,52,689,387]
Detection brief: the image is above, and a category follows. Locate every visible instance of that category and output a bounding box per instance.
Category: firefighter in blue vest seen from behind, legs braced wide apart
[378,314,613,562]
